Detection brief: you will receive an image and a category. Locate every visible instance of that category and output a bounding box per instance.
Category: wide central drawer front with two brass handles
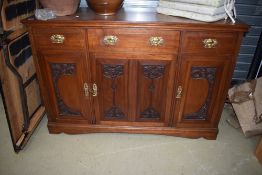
[88,28,180,53]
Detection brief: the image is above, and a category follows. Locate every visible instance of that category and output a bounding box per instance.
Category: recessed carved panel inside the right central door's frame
[137,61,170,121]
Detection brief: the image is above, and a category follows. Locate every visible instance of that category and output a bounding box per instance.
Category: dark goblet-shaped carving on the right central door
[140,65,165,119]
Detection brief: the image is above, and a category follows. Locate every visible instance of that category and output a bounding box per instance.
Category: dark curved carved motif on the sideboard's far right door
[185,66,217,120]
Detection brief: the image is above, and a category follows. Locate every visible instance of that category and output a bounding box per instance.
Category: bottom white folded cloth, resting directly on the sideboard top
[157,7,227,22]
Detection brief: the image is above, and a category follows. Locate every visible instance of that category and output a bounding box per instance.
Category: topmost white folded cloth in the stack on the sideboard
[160,0,225,7]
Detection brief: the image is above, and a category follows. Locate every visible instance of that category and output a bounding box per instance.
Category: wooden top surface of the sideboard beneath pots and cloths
[22,8,248,31]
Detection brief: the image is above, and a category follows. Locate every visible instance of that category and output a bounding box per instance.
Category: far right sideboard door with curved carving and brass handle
[175,56,232,127]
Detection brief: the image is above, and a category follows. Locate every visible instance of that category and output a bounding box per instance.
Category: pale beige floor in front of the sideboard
[0,98,262,175]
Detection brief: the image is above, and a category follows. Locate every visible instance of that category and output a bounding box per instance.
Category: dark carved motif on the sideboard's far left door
[50,63,80,115]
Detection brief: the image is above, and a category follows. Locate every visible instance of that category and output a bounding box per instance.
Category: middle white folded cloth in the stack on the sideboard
[158,0,226,16]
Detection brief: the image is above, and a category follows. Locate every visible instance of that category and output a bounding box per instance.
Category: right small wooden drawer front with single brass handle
[182,32,237,55]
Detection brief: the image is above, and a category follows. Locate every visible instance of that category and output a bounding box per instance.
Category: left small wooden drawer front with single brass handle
[33,28,85,50]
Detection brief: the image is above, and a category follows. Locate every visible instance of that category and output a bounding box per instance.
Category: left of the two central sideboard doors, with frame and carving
[91,53,129,124]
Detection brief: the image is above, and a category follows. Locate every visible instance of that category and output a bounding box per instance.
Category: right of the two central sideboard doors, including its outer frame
[136,56,175,125]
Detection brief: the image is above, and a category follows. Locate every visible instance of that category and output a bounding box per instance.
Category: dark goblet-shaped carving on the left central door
[103,64,126,118]
